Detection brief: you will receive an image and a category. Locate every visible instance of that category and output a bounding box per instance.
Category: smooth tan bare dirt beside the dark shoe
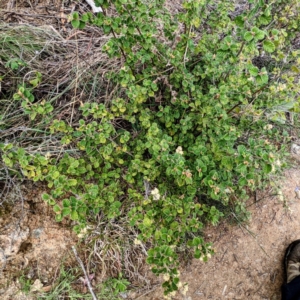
[143,168,300,300]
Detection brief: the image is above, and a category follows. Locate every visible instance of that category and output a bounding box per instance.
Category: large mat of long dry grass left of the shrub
[0,24,119,146]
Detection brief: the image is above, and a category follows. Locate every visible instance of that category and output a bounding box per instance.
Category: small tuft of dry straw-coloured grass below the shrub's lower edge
[84,217,151,288]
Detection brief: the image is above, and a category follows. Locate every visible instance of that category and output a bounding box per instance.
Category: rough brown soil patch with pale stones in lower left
[0,183,77,300]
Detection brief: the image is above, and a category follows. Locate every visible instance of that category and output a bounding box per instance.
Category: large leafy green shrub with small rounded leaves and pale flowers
[0,0,300,293]
